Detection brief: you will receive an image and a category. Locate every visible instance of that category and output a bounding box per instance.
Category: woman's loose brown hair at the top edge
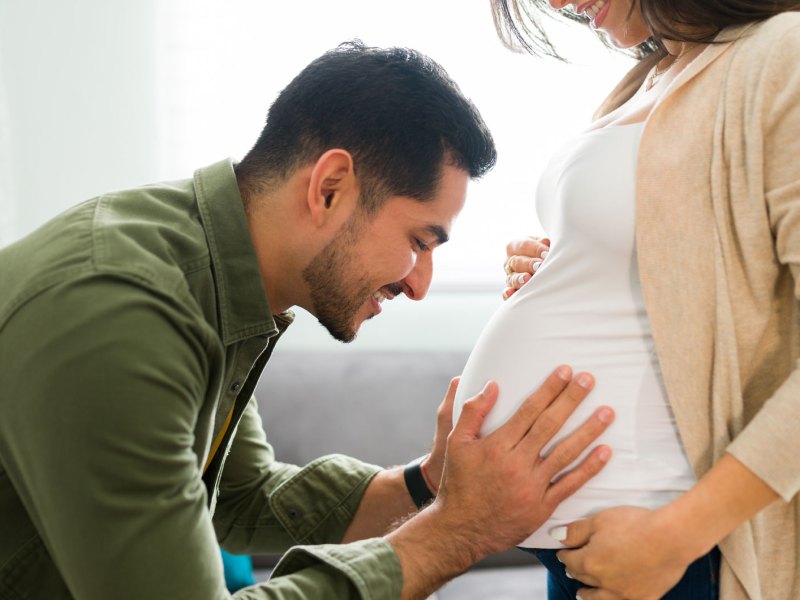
[492,0,800,59]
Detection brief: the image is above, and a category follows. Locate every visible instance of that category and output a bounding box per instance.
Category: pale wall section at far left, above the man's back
[0,0,160,245]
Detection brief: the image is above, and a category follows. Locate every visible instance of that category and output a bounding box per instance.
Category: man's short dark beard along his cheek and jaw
[303,216,375,343]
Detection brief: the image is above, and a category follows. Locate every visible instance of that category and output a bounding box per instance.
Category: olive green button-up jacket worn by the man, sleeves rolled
[0,161,402,600]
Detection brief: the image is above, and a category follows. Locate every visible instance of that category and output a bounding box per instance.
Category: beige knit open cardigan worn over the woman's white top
[598,13,800,600]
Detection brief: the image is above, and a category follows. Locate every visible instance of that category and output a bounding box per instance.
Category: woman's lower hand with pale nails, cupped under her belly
[551,506,700,600]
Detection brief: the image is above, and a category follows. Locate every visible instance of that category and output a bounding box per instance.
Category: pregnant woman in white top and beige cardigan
[456,0,800,600]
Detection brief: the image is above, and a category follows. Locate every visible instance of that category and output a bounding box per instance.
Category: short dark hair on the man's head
[236,41,497,214]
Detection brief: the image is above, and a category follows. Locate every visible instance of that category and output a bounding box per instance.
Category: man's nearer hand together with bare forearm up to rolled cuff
[386,367,614,598]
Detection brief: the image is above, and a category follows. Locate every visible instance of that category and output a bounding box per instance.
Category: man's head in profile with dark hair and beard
[236,42,496,341]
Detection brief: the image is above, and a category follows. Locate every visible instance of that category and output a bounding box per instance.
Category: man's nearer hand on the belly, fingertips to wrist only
[439,367,613,553]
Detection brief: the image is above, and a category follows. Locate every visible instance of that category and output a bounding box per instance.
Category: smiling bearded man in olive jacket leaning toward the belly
[0,44,607,599]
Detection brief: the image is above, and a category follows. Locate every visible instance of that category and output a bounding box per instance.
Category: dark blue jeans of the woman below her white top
[520,548,720,600]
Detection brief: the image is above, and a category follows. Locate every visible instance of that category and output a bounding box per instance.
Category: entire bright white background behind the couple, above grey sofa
[0,0,628,351]
